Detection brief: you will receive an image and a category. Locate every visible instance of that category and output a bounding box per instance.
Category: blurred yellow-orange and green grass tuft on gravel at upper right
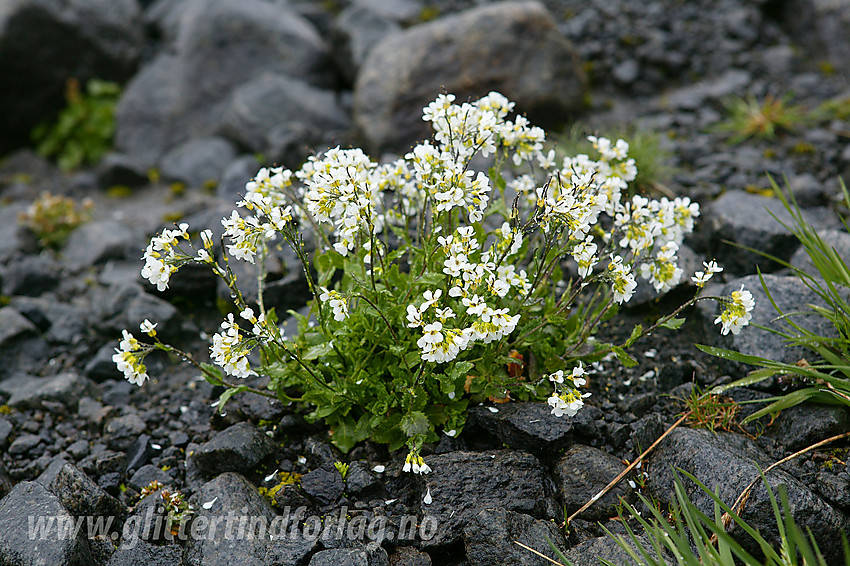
[717,94,807,144]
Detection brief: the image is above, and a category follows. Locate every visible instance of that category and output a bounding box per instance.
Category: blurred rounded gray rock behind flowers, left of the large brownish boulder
[221,73,350,165]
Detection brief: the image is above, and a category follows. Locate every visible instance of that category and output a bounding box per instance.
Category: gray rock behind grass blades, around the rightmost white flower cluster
[707,274,836,364]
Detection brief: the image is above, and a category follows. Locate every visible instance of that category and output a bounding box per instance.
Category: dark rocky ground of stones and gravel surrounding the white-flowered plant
[0,0,850,566]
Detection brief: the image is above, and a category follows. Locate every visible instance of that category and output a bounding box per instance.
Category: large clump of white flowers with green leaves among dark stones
[114,92,753,473]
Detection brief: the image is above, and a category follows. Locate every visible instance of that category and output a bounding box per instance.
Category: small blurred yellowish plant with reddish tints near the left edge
[18,191,94,249]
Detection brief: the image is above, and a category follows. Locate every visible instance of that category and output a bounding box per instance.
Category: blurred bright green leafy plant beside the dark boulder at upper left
[32,79,121,170]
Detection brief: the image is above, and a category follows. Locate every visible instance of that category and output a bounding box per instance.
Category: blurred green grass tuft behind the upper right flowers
[555,125,676,194]
